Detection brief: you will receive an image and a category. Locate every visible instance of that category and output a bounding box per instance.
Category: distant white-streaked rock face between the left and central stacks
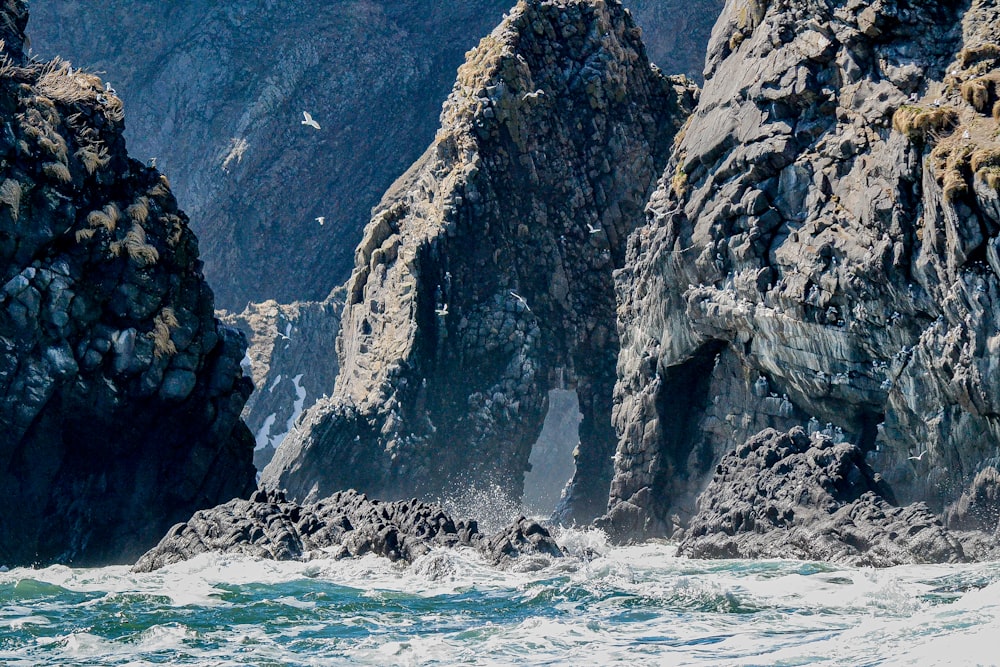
[220,289,344,470]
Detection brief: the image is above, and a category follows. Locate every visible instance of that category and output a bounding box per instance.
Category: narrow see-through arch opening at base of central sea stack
[521,389,583,517]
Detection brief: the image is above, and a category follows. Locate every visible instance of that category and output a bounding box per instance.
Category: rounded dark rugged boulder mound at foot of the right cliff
[678,427,965,567]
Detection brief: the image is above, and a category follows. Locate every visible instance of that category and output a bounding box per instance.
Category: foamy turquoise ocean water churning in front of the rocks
[0,531,1000,666]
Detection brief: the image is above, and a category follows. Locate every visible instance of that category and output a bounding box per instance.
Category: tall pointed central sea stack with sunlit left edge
[261,0,695,520]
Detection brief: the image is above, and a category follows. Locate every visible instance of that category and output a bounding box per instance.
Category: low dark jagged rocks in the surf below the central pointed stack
[134,491,562,572]
